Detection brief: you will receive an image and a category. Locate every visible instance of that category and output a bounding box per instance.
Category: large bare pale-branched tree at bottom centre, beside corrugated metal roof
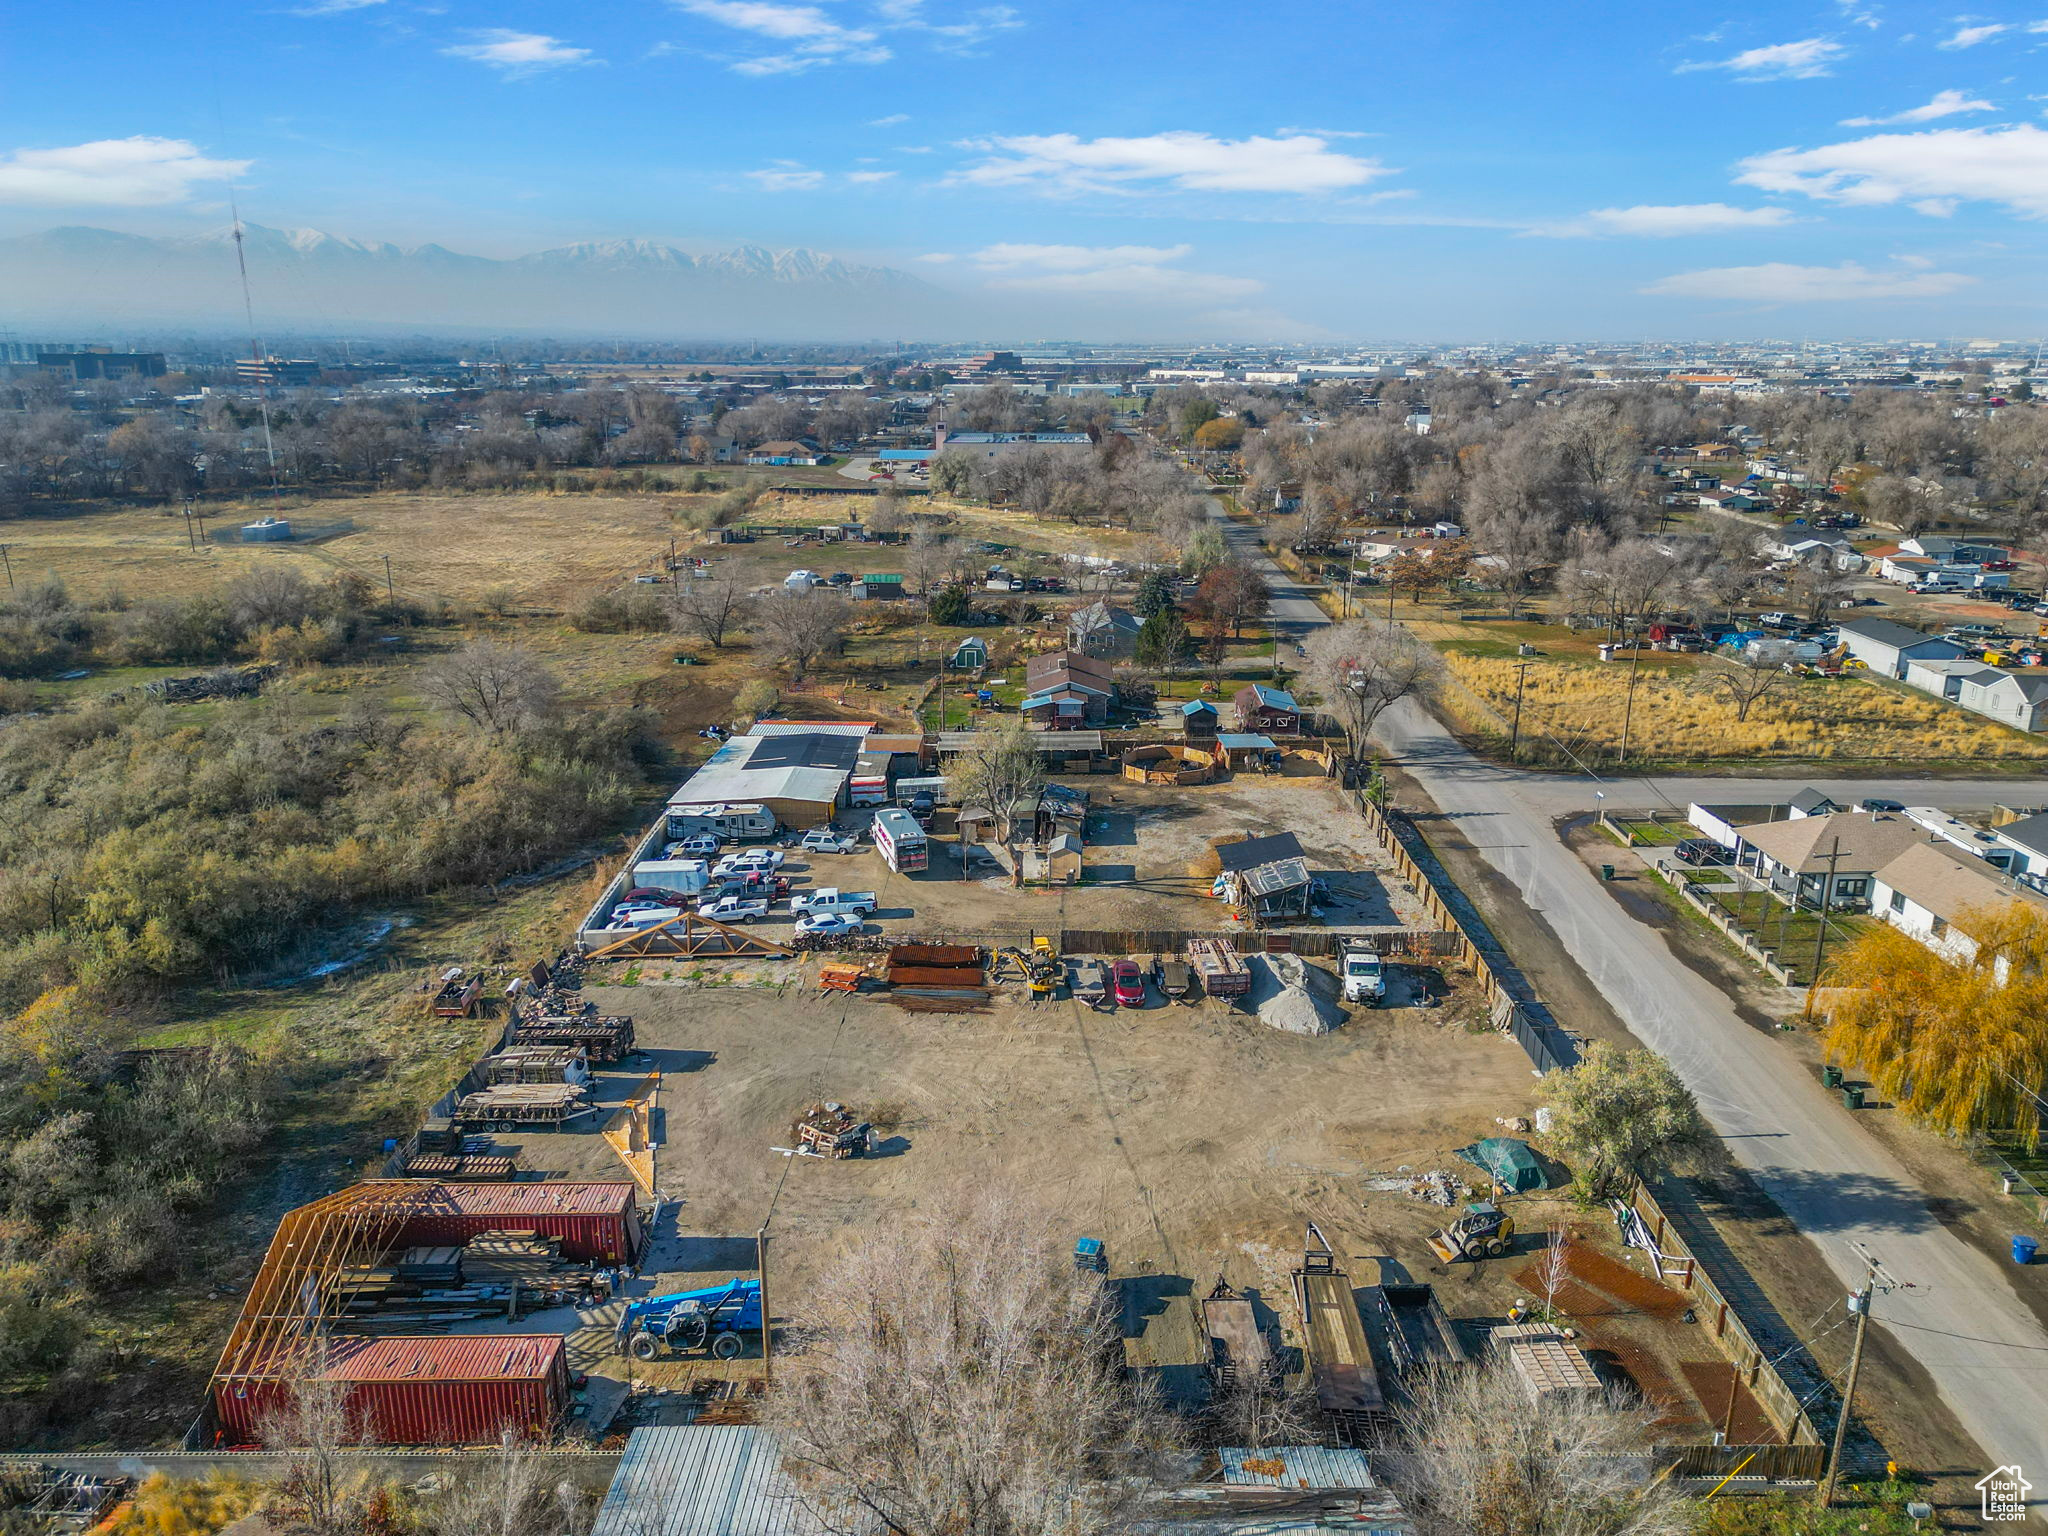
[766,1186,1171,1536]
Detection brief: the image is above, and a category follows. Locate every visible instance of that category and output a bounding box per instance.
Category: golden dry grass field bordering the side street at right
[1444,651,2048,762]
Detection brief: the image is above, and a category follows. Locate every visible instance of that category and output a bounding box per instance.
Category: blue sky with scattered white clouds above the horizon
[12,0,2048,340]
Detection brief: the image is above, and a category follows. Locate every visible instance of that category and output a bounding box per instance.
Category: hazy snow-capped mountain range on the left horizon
[0,225,954,340]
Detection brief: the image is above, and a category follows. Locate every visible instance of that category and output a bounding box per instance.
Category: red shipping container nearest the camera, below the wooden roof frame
[213,1333,569,1446]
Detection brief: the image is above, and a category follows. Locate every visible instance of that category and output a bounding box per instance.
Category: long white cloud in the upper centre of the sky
[954,131,1389,193]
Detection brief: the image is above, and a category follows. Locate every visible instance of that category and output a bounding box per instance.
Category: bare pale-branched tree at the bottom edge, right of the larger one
[1376,1356,1692,1536]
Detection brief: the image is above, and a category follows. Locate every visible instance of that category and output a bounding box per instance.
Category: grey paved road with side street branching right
[1227,512,2048,1522]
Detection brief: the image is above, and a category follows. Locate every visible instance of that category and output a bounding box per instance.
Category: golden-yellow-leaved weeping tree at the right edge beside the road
[1825,901,2048,1147]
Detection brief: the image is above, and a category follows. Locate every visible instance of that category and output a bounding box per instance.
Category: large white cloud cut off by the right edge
[1737,123,2048,217]
